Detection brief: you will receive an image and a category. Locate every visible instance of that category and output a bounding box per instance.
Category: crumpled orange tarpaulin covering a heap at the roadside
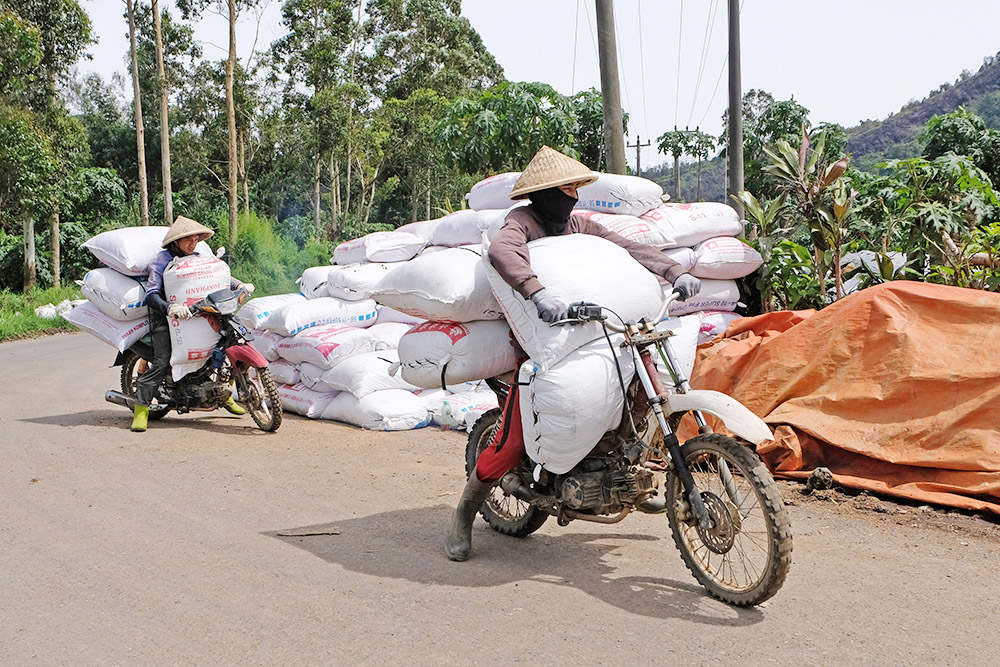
[691,281,1000,514]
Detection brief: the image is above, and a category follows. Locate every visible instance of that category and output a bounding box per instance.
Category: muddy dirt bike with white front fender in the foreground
[466,292,792,606]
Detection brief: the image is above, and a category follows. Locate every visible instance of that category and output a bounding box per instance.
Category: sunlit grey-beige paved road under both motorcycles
[0,334,1000,667]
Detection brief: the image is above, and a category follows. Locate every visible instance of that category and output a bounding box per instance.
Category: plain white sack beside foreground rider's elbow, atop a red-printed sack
[372,246,503,322]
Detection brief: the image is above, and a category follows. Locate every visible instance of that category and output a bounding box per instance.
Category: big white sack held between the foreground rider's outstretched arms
[483,234,663,370]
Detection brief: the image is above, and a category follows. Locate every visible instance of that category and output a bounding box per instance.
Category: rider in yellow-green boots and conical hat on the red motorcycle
[132,216,254,432]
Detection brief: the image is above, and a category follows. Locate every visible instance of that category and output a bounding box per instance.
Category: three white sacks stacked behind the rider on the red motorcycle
[64,227,212,352]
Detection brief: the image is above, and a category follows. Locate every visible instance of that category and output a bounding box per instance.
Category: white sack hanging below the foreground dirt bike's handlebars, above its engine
[518,340,636,475]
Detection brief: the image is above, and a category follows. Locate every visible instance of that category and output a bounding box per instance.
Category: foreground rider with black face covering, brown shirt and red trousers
[445,146,701,561]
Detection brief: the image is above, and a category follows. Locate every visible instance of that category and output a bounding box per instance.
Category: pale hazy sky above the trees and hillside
[79,0,1000,167]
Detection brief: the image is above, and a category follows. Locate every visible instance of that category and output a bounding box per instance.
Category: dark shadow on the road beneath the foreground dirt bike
[264,505,764,627]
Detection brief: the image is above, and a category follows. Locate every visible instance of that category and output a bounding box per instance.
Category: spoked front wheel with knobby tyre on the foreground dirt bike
[666,434,792,607]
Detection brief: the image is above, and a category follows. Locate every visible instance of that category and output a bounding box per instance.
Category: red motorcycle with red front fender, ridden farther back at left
[104,286,282,432]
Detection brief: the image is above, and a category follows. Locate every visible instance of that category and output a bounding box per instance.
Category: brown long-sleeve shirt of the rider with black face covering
[489,206,684,299]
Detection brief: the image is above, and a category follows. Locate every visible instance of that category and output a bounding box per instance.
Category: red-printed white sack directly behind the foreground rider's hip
[397,320,517,389]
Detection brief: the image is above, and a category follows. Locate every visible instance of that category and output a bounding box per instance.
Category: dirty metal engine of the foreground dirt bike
[560,466,658,514]
